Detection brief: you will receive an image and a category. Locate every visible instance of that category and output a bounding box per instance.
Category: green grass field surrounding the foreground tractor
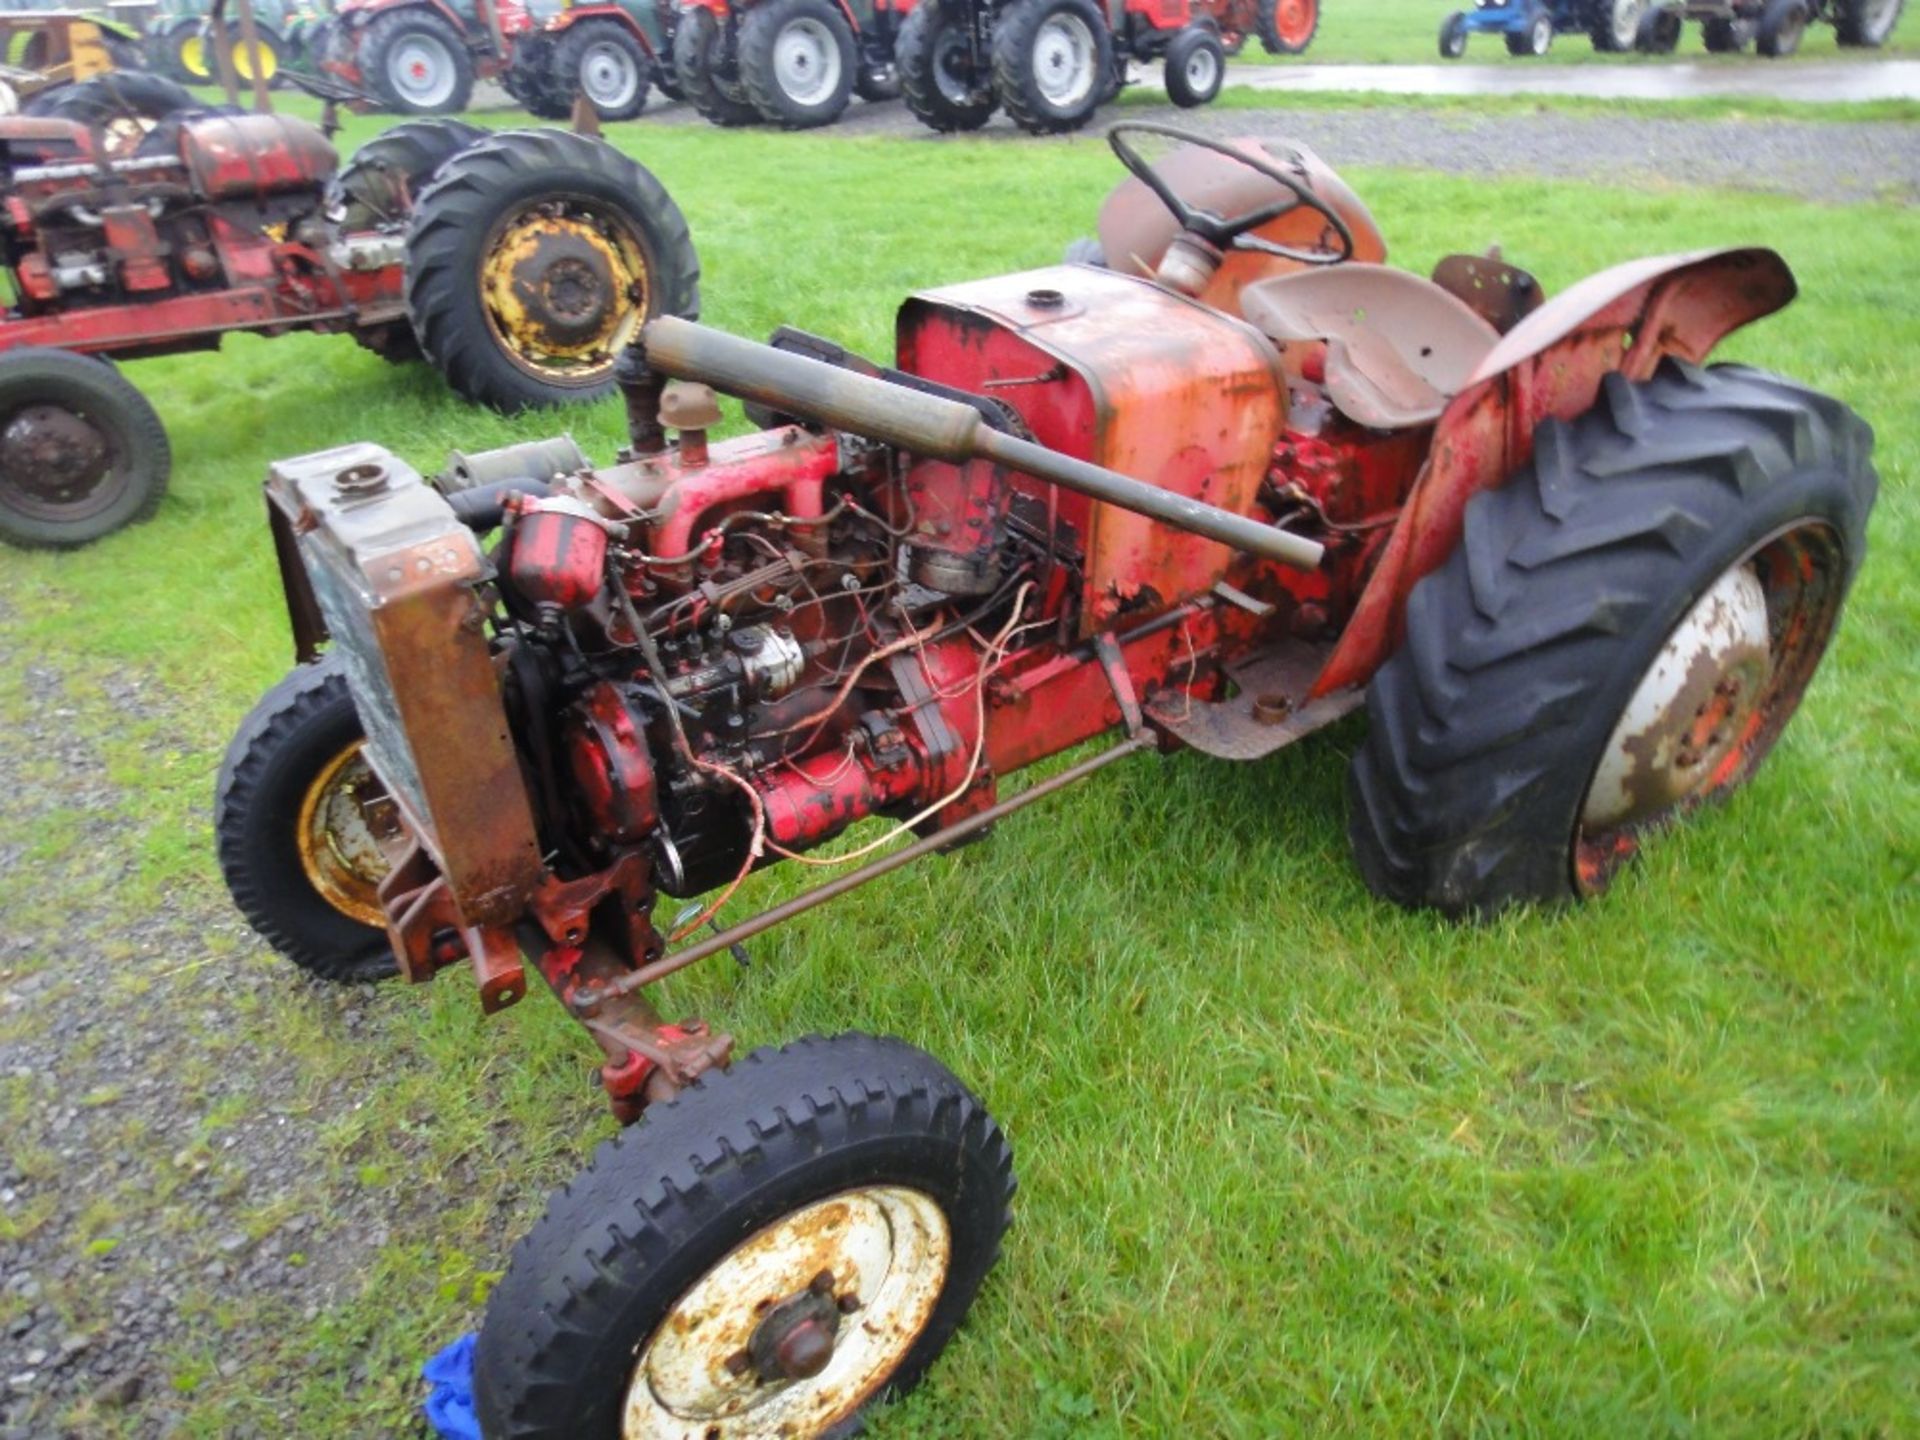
[0,118,1920,1440]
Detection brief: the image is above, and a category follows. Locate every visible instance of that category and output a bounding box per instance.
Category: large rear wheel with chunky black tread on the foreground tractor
[1350,361,1878,914]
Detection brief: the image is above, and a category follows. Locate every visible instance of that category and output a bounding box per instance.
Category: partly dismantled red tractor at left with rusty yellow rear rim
[0,109,699,547]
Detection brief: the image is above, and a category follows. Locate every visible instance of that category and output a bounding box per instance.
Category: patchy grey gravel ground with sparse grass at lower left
[0,637,401,1440]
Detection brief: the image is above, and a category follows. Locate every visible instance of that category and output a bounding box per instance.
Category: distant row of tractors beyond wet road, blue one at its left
[1440,0,1907,60]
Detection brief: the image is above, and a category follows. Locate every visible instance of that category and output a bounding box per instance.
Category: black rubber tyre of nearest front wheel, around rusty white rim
[474,1035,1014,1440]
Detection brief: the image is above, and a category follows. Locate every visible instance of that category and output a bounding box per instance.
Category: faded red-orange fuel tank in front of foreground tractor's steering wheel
[897,265,1286,634]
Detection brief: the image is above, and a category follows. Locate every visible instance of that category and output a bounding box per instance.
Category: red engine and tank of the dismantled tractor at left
[0,115,367,337]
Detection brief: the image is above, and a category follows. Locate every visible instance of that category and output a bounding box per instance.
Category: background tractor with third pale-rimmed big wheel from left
[674,0,914,129]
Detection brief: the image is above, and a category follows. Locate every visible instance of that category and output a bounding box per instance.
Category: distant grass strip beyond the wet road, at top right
[1240,0,1920,65]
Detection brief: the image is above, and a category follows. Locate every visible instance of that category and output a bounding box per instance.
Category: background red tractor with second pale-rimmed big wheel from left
[501,0,680,121]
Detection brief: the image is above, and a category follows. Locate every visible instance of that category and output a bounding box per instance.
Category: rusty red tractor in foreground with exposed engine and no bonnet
[217,125,1878,1440]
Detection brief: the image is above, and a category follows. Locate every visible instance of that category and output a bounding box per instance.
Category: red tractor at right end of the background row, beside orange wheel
[897,0,1319,134]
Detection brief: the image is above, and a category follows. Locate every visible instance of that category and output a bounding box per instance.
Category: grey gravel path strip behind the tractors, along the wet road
[625,102,1920,205]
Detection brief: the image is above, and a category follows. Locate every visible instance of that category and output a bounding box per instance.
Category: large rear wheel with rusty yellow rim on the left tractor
[407,131,701,413]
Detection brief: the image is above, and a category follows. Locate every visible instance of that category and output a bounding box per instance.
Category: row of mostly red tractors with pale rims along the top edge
[317,0,1319,132]
